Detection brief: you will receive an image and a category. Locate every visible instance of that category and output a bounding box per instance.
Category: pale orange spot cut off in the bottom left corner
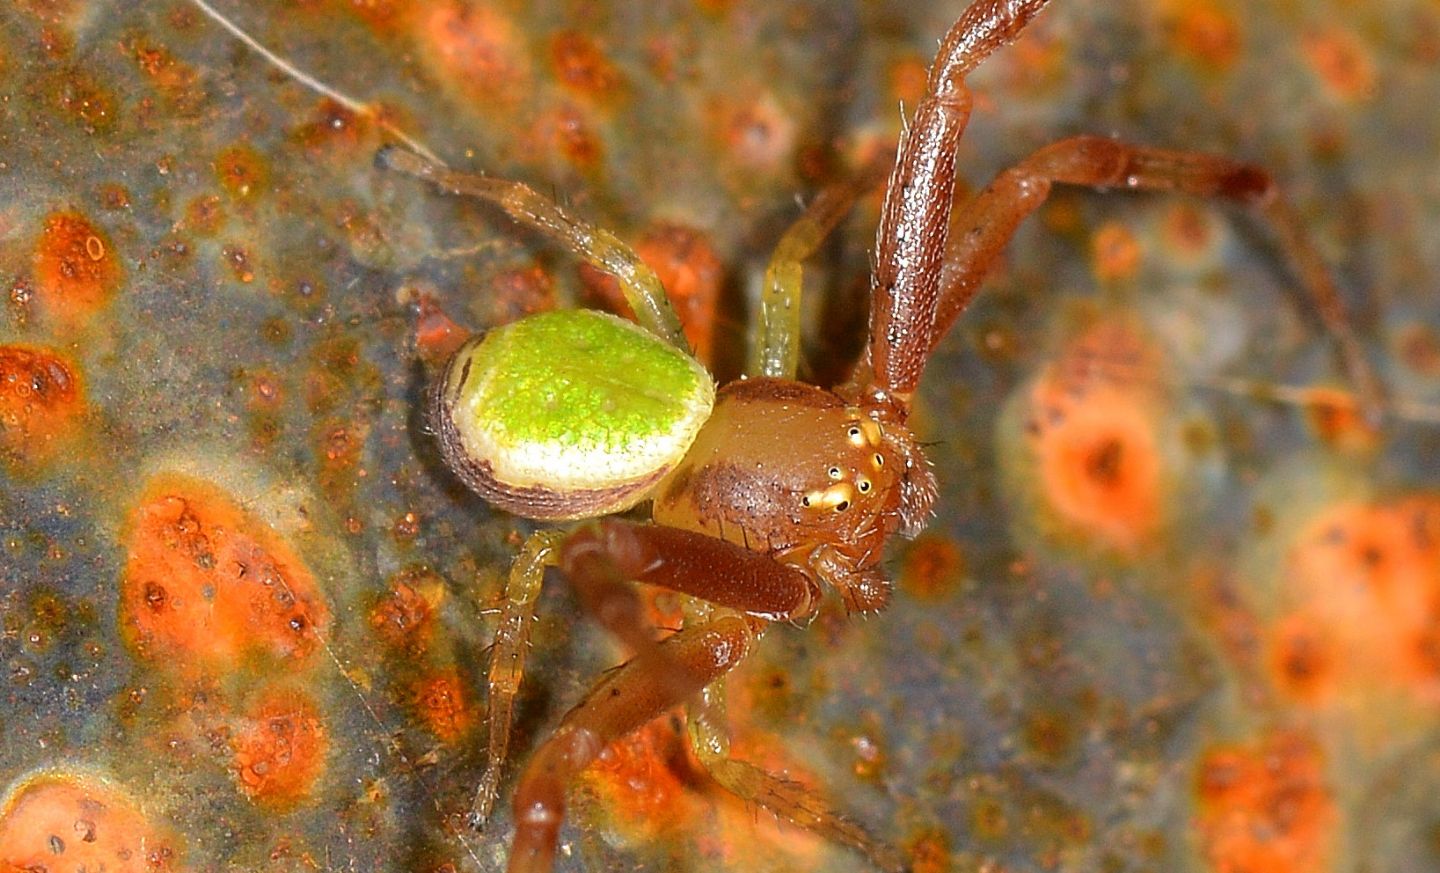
[0,775,181,873]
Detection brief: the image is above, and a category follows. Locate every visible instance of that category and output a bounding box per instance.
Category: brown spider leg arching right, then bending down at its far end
[926,137,1382,411]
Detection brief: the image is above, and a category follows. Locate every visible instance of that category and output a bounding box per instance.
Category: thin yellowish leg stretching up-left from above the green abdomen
[376,146,690,353]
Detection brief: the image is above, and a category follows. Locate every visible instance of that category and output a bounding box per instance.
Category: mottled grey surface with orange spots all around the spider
[0,0,1440,873]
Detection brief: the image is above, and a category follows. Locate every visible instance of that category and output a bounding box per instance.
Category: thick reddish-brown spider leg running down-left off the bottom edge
[510,615,755,873]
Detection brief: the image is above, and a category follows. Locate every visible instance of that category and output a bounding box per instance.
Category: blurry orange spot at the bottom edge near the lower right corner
[1195,732,1338,873]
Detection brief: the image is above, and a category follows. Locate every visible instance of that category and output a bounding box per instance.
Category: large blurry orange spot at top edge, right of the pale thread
[416,3,533,107]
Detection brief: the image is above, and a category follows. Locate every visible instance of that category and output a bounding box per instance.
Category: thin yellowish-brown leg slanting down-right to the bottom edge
[685,681,904,870]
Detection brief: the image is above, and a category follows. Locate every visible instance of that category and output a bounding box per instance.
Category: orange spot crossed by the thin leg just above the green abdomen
[580,223,724,363]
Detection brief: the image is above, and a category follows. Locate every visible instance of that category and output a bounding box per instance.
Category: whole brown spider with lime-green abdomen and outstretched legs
[379,0,1380,870]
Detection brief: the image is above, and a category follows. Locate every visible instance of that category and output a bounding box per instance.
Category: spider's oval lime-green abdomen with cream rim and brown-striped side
[432,310,714,520]
